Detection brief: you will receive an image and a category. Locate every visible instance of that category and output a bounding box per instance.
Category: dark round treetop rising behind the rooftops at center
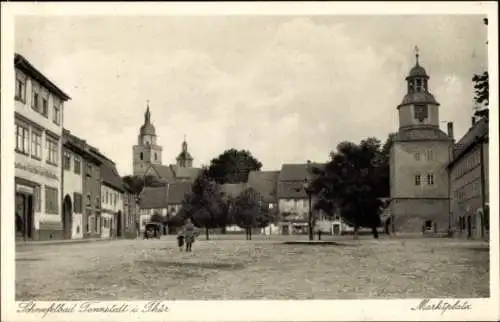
[208,149,262,184]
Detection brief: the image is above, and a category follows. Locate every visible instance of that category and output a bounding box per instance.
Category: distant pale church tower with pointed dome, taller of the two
[132,102,163,176]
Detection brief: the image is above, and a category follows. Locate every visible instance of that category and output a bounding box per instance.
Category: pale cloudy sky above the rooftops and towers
[15,15,487,175]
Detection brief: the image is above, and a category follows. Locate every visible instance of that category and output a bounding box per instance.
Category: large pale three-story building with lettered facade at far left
[14,54,70,240]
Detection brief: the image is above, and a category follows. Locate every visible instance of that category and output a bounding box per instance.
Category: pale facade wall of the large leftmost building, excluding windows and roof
[15,69,64,239]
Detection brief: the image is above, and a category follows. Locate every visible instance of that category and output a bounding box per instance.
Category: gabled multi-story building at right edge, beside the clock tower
[448,117,489,238]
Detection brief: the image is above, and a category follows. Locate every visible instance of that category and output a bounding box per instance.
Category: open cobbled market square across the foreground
[16,236,490,301]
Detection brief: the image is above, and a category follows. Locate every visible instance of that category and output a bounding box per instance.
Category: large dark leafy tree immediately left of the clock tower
[312,138,389,238]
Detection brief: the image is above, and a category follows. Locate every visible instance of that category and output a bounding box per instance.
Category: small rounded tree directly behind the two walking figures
[182,169,225,240]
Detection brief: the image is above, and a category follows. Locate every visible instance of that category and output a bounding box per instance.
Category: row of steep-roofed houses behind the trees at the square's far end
[140,162,349,235]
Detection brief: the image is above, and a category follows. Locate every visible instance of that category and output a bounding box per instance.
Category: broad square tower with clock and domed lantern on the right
[389,48,453,234]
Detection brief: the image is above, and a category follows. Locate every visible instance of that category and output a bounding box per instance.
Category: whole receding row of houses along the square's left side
[14,54,138,240]
